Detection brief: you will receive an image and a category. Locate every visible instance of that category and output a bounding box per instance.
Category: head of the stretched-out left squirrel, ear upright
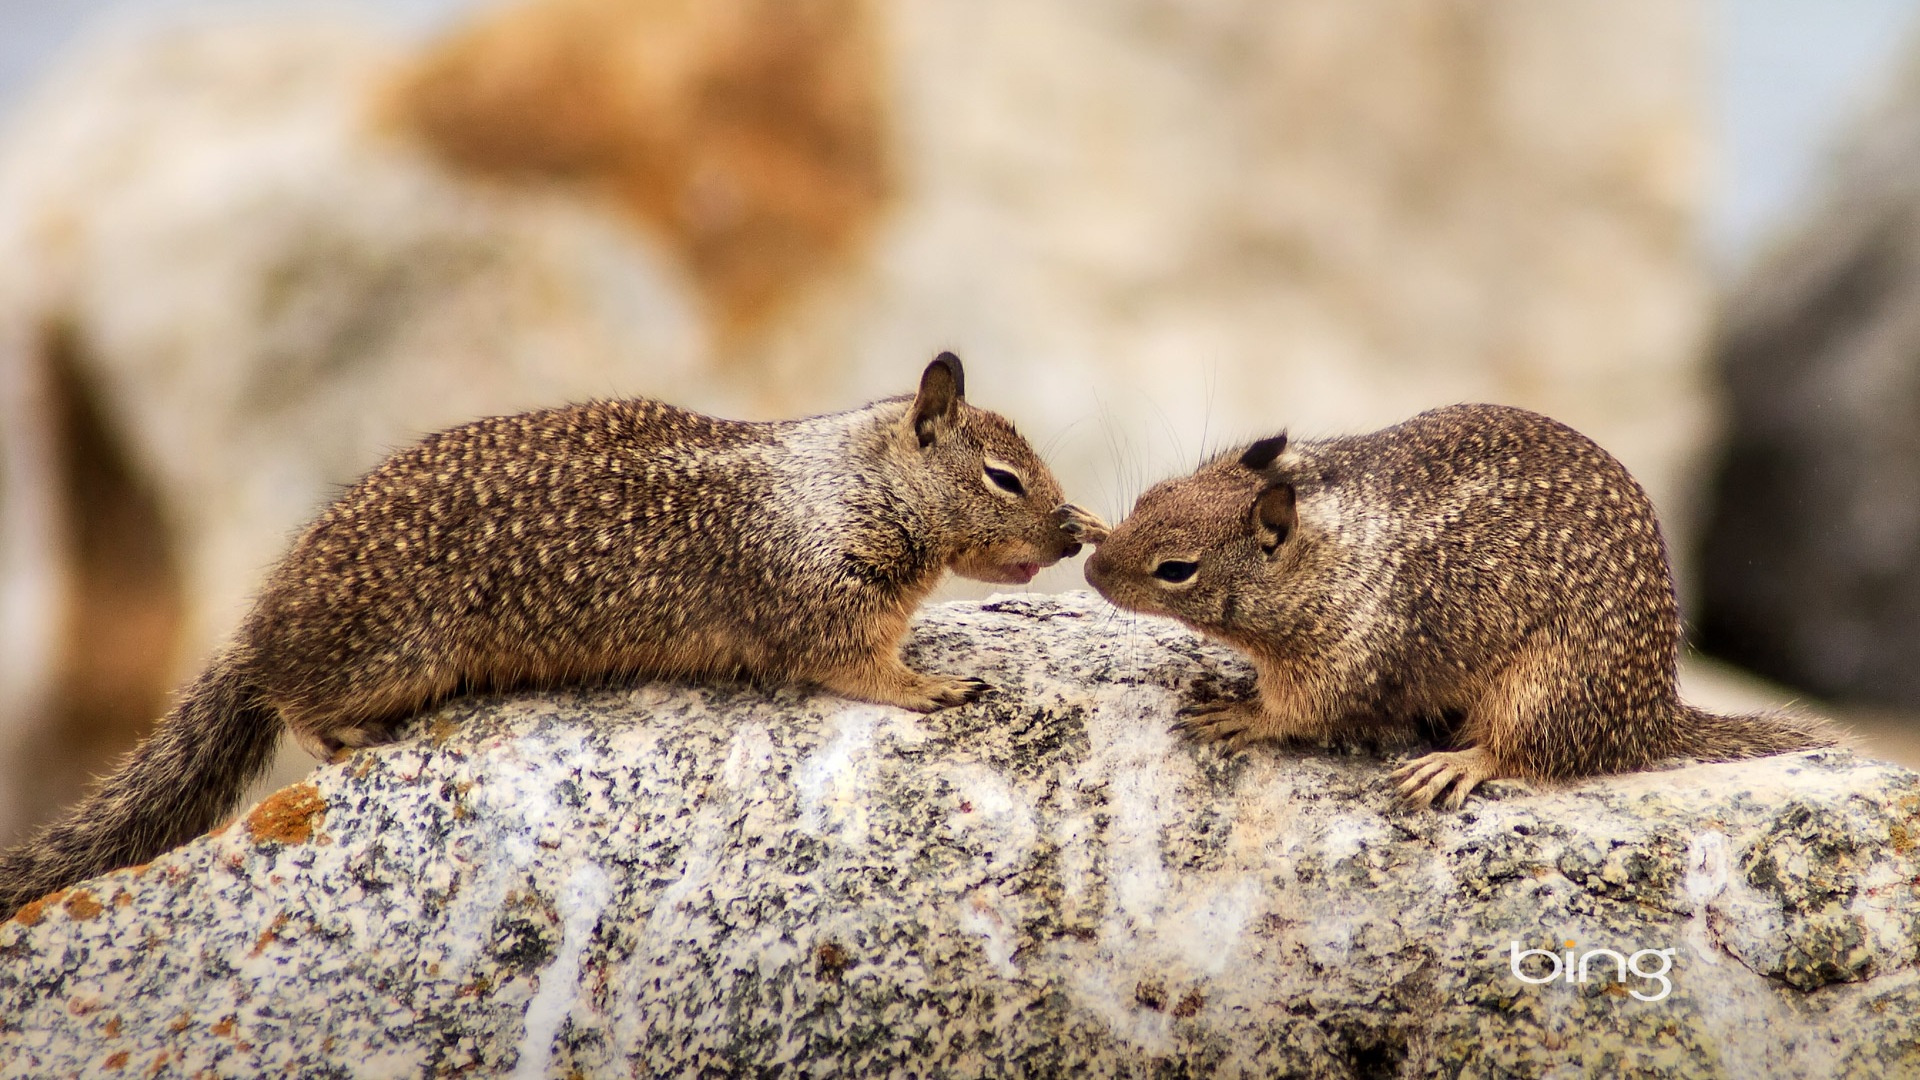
[899,352,1106,584]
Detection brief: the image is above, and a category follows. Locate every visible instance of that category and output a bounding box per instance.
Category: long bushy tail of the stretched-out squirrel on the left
[0,653,280,919]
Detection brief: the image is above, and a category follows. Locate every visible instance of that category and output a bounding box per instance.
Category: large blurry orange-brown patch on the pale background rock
[380,0,893,340]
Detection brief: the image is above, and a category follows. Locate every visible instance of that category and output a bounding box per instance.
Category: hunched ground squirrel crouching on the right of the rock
[1087,405,1836,807]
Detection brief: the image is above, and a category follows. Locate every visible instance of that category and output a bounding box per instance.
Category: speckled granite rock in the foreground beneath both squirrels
[0,594,1920,1078]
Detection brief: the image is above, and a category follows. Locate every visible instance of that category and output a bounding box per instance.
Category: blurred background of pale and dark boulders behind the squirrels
[0,0,1920,838]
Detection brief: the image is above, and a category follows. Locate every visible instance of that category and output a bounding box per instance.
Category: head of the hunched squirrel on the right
[1087,434,1302,634]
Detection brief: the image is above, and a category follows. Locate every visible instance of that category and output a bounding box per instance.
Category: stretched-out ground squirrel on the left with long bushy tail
[0,354,1098,917]
